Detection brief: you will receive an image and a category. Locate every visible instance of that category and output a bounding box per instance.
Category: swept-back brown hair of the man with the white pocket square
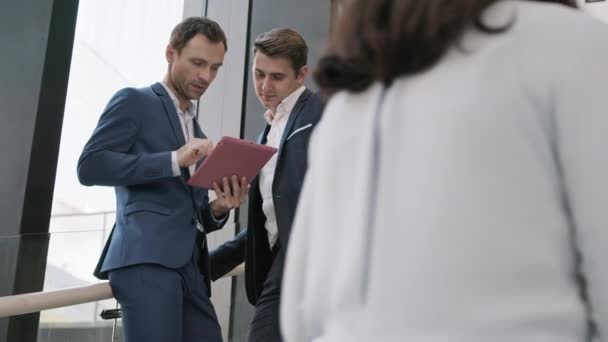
[253,28,308,74]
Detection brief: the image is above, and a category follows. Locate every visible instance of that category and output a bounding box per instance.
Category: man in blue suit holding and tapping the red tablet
[78,17,248,342]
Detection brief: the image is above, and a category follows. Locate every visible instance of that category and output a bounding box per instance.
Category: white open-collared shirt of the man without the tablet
[260,86,306,248]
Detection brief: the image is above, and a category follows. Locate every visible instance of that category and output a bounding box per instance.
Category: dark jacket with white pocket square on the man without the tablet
[211,90,323,304]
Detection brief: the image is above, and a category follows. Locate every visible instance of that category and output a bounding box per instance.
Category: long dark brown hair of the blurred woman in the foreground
[315,0,576,95]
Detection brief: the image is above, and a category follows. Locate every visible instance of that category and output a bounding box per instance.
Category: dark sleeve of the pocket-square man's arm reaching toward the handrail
[209,229,247,281]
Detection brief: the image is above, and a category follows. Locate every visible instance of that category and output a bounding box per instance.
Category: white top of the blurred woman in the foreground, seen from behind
[281,1,608,342]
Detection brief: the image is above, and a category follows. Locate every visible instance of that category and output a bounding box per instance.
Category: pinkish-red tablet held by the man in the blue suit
[188,136,277,189]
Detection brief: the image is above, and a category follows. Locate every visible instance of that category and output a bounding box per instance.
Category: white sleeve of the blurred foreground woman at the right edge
[554,18,608,341]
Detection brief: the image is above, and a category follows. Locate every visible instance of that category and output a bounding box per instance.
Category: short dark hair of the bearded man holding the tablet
[169,17,228,53]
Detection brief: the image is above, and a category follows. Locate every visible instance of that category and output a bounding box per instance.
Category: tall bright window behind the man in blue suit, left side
[38,0,183,342]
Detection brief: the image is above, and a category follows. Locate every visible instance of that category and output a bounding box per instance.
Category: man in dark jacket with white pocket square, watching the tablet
[211,29,323,342]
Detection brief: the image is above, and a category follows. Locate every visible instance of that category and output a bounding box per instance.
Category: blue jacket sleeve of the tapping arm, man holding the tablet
[78,89,173,186]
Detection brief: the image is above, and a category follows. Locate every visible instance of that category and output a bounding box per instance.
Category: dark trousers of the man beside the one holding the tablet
[248,242,285,342]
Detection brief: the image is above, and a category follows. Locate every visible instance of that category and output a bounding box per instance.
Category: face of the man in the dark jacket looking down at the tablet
[253,51,308,113]
